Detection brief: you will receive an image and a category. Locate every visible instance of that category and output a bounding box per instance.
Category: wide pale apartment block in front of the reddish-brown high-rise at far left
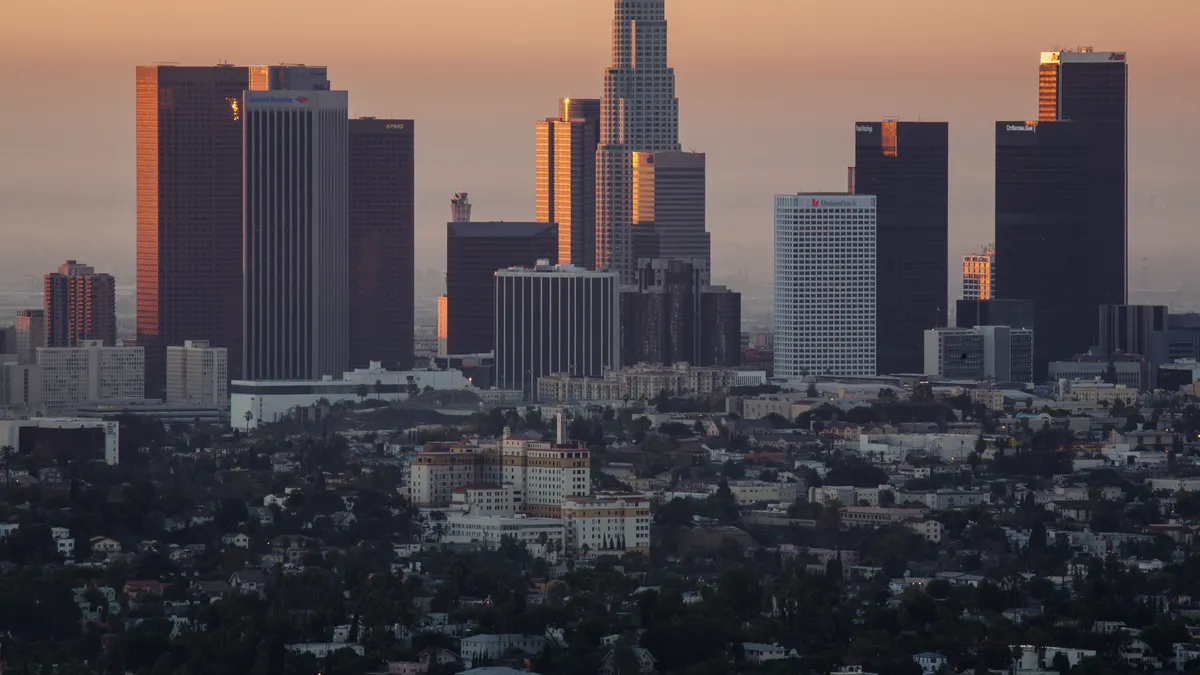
[37,340,145,414]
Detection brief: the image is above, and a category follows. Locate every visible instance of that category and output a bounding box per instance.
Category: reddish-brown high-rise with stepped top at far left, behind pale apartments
[43,261,116,347]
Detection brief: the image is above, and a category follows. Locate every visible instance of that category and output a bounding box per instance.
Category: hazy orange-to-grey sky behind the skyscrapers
[0,0,1200,299]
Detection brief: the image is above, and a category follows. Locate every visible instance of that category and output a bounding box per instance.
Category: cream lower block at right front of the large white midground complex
[563,492,650,555]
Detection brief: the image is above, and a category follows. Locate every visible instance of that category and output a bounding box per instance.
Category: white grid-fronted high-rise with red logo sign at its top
[774,192,876,378]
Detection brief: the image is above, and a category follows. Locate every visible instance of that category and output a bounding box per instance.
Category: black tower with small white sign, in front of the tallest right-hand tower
[994,121,1094,378]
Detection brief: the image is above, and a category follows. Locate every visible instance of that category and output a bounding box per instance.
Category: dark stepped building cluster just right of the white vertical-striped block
[620,258,742,365]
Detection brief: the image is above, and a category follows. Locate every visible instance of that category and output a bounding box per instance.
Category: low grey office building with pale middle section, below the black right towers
[924,325,1033,382]
